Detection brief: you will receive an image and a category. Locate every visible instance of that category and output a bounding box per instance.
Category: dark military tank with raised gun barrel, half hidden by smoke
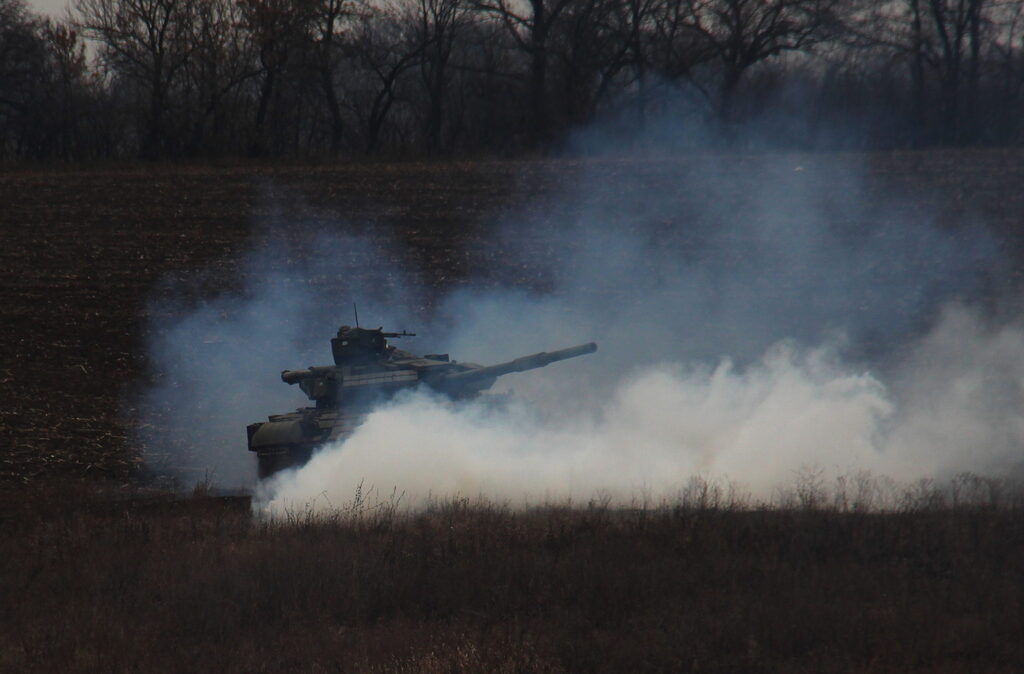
[247,326,597,479]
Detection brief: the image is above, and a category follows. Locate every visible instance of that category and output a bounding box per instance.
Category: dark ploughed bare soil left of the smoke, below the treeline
[0,159,536,481]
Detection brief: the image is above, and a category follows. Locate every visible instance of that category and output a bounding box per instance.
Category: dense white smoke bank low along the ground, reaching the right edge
[266,306,1024,512]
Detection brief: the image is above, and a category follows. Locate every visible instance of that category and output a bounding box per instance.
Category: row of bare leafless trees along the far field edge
[0,0,1024,161]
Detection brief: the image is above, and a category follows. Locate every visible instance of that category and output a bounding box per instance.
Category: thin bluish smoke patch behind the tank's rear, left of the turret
[136,222,420,488]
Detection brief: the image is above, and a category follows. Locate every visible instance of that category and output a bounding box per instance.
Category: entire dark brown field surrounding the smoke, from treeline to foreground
[0,151,1024,672]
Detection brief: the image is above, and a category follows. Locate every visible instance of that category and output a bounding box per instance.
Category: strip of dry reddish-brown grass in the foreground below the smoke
[0,480,1024,672]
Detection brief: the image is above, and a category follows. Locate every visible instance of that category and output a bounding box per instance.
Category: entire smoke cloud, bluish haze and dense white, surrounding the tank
[138,149,1024,511]
